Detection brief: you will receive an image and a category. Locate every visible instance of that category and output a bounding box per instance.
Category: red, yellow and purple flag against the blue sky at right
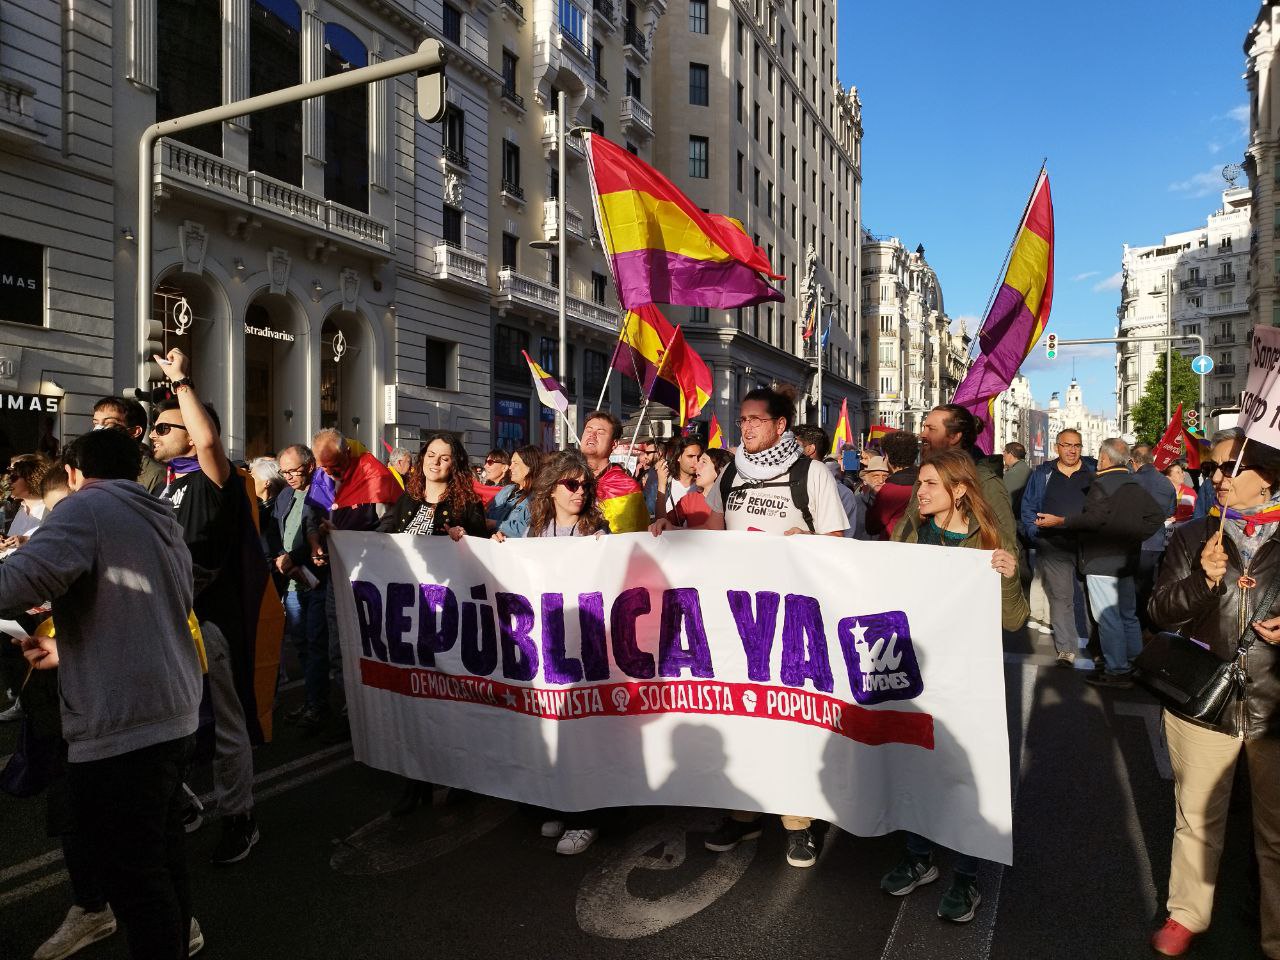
[954,170,1053,453]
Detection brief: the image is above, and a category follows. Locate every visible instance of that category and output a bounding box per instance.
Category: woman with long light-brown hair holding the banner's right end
[881,449,1028,923]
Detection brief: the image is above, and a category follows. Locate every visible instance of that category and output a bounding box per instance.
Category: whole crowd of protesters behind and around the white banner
[0,351,1280,960]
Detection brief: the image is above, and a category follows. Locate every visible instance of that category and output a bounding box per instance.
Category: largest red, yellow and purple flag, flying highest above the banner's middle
[585,133,785,310]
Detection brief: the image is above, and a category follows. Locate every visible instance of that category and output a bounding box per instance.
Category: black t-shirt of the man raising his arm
[163,470,248,623]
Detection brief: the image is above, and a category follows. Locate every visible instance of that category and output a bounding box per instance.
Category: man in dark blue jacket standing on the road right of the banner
[1018,430,1097,667]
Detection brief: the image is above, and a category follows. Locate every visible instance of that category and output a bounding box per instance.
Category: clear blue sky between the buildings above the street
[838,0,1258,413]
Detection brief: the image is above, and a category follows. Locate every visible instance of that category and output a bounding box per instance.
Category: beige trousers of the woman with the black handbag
[1165,710,1280,957]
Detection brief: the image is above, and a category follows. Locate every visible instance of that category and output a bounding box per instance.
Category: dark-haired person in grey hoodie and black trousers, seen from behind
[0,430,201,960]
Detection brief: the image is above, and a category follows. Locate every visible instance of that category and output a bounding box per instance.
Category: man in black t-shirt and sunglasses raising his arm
[151,349,266,865]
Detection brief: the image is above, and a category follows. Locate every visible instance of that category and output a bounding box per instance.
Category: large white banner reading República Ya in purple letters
[333,531,1012,864]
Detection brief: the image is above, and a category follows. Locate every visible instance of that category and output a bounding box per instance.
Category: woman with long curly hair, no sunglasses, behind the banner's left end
[378,433,489,540]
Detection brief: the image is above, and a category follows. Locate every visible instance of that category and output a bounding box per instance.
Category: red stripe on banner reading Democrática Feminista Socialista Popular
[360,658,933,750]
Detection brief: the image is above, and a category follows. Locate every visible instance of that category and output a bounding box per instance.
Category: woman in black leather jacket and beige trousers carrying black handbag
[1137,434,1280,960]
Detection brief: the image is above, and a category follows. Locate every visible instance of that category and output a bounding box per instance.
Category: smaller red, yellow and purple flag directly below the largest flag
[612,303,712,426]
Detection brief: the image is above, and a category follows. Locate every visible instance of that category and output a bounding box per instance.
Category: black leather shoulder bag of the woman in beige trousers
[1133,571,1280,726]
